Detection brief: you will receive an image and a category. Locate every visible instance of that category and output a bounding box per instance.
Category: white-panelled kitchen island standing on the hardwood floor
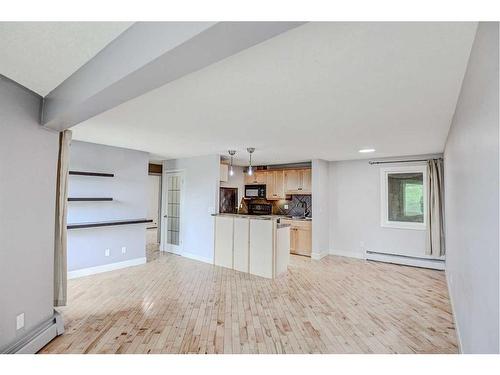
[213,214,290,278]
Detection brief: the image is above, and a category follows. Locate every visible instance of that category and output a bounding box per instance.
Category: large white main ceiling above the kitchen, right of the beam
[73,23,477,164]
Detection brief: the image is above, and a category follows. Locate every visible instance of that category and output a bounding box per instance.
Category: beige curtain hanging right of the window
[426,159,445,257]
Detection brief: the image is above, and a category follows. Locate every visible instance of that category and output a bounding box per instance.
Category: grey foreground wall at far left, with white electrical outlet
[0,76,59,351]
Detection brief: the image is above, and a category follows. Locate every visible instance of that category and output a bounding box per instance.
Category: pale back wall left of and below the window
[328,155,437,258]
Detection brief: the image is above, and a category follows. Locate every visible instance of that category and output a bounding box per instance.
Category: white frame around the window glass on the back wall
[380,164,429,230]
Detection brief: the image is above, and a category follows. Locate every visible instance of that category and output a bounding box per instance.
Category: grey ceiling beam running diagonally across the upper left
[41,22,304,130]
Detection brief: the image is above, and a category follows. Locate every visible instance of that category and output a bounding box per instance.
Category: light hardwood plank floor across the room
[40,252,457,353]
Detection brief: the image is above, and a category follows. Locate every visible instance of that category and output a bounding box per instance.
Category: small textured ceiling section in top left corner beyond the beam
[0,22,132,96]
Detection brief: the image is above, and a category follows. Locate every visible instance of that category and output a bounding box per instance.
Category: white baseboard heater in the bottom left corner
[1,310,64,354]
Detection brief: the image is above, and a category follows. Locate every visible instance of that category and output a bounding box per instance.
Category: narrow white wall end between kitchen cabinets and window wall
[311,159,330,259]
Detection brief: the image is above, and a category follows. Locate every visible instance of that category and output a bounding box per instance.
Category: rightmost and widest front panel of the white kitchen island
[249,220,274,278]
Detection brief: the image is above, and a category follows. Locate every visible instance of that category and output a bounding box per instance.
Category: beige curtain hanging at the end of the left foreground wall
[54,130,71,306]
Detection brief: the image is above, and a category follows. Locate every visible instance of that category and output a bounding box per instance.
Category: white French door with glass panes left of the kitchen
[162,172,184,254]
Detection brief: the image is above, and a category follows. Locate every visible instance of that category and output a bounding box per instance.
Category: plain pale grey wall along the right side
[444,22,499,353]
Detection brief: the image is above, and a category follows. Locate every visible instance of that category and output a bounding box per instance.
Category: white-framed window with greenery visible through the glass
[380,166,427,230]
